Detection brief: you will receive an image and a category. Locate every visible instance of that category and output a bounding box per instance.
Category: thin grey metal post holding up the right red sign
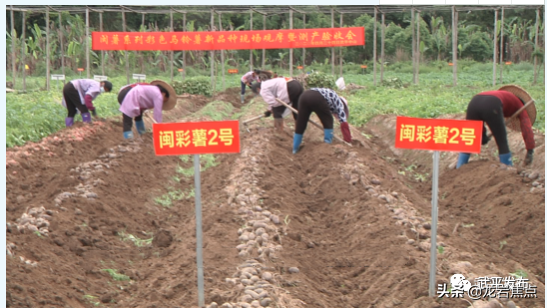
[429,151,440,297]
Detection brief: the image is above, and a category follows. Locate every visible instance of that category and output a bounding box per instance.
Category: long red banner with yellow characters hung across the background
[92,27,365,50]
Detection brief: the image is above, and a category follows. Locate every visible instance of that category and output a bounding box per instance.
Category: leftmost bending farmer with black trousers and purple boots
[63,79,112,127]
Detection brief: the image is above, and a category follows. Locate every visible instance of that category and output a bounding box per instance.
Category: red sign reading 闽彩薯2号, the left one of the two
[153,121,240,155]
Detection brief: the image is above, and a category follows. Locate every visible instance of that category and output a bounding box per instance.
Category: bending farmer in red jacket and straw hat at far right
[456,85,536,169]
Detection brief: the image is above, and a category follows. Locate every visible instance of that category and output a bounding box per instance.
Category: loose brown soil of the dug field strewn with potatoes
[6,89,545,308]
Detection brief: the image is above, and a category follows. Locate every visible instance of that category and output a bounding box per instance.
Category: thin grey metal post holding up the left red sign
[194,154,205,307]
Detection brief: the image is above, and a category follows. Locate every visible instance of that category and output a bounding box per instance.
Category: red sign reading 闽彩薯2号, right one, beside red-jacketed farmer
[395,117,483,153]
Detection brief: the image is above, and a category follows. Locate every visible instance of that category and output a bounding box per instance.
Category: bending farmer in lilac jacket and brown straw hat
[118,80,177,139]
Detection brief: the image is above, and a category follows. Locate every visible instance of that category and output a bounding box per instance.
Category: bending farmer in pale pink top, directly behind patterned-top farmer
[252,78,304,132]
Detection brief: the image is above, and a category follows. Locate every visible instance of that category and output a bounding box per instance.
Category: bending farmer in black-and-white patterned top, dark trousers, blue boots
[293,88,351,154]
